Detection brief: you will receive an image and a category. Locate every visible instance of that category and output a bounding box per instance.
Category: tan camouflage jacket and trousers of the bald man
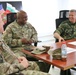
[3,21,50,72]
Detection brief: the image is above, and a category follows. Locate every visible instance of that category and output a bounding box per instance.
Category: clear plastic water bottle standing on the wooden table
[61,41,67,61]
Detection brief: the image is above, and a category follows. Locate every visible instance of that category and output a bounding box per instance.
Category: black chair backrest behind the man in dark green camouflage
[55,10,69,42]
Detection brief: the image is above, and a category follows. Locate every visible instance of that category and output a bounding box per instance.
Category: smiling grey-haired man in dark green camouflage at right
[54,10,76,42]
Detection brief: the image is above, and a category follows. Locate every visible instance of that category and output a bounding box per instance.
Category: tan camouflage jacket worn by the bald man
[3,21,38,47]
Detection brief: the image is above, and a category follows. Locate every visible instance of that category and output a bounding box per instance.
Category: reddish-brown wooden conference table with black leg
[22,39,76,75]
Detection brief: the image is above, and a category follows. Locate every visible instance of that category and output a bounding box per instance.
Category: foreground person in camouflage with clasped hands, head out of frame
[0,41,50,75]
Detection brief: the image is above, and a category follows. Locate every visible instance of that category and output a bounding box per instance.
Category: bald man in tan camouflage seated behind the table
[3,10,50,72]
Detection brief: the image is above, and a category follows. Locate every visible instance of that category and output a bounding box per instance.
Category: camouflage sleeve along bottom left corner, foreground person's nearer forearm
[0,62,25,75]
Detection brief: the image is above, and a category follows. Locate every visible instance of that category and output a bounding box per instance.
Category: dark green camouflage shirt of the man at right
[55,20,76,40]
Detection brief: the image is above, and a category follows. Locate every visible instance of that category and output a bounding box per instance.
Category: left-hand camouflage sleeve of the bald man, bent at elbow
[2,25,22,47]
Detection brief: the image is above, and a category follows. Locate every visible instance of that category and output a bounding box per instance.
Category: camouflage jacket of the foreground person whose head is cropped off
[0,41,24,75]
